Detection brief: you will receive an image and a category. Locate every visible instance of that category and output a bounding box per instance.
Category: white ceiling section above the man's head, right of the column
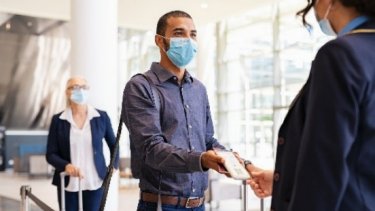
[118,0,272,28]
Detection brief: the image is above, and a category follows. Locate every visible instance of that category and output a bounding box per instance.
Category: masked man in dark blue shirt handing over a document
[122,11,224,210]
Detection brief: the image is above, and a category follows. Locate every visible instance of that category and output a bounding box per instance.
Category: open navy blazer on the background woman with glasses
[46,109,119,186]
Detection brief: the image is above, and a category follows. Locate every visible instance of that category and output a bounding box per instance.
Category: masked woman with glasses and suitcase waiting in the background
[46,77,118,211]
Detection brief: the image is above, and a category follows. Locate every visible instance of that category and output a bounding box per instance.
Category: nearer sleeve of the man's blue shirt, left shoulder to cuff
[122,76,202,173]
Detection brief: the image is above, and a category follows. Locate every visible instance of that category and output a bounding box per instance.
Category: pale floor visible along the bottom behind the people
[0,171,270,211]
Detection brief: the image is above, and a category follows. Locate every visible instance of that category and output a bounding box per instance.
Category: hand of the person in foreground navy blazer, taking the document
[246,165,273,198]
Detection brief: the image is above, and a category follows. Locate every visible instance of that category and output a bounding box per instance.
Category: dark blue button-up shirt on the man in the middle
[123,63,224,197]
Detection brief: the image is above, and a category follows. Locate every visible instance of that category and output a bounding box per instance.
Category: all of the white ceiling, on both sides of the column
[0,0,276,29]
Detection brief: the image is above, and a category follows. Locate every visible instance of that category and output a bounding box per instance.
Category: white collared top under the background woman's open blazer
[60,106,103,192]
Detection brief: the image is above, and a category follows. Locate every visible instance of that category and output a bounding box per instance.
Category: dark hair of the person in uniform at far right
[296,0,375,26]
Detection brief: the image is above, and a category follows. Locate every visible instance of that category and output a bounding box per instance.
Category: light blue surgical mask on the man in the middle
[160,37,197,68]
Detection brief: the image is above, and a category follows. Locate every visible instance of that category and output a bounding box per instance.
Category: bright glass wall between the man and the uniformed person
[216,1,329,165]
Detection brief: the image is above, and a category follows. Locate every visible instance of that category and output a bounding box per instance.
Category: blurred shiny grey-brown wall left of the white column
[0,16,70,129]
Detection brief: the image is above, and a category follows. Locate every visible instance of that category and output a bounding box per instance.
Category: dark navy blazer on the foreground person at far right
[271,20,375,211]
